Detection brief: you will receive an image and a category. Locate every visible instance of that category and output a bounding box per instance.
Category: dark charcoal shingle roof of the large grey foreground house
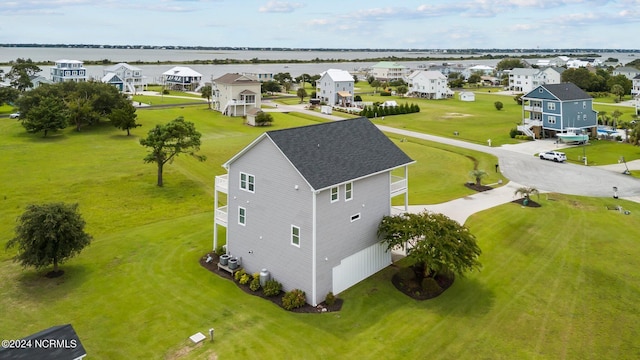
[266,117,413,190]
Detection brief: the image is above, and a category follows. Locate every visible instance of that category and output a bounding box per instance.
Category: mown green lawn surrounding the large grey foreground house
[0,102,640,359]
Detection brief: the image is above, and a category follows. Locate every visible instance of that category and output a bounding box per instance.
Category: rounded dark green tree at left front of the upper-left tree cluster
[20,96,68,137]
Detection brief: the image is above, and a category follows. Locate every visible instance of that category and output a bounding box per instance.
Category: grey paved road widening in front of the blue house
[270,105,640,202]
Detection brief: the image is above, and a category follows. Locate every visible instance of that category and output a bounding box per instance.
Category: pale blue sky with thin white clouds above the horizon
[0,0,640,50]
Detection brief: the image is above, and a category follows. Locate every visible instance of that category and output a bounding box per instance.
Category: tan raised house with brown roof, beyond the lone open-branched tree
[211,74,262,116]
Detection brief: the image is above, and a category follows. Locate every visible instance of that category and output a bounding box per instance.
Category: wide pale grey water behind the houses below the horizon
[0,47,640,83]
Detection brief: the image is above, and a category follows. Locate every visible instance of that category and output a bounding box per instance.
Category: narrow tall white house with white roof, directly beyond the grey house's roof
[316,69,355,107]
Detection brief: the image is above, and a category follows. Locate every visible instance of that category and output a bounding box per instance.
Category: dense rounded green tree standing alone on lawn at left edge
[6,203,92,272]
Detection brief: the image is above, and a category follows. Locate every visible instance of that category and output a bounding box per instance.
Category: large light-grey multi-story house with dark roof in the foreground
[213,118,414,306]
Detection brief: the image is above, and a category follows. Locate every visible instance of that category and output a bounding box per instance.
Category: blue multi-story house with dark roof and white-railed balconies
[518,83,598,138]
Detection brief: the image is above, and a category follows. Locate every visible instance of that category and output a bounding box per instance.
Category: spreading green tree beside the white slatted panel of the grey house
[378,211,481,277]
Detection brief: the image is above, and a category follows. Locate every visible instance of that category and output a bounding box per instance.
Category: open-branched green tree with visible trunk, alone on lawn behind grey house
[140,116,206,186]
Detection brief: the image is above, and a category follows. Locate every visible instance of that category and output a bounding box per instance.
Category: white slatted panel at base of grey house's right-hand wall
[333,243,391,295]
